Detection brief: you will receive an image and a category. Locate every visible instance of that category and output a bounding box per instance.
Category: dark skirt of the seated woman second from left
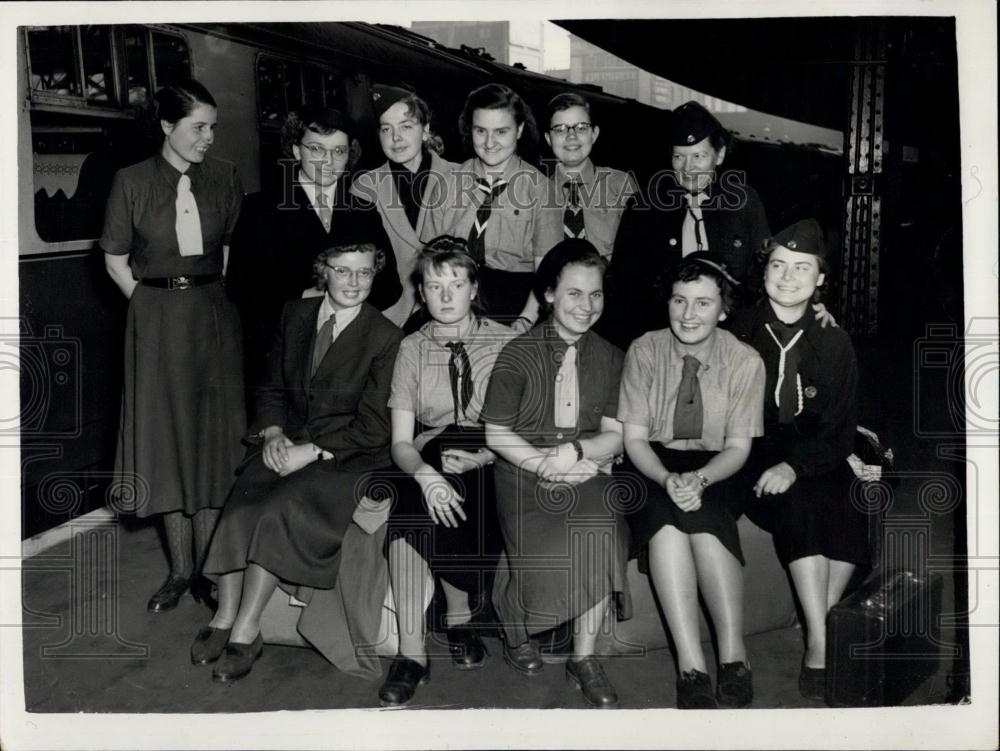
[386,425,502,593]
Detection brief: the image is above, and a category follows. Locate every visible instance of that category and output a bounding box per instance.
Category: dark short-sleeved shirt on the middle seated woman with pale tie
[482,321,624,446]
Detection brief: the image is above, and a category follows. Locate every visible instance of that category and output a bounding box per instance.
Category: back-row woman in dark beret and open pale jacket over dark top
[351,85,458,326]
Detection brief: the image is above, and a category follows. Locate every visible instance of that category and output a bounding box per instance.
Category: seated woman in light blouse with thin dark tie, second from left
[379,237,514,706]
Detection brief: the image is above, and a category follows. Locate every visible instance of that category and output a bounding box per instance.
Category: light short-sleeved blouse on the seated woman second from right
[618,329,764,451]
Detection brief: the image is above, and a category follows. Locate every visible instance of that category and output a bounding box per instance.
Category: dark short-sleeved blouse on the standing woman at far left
[101,154,243,279]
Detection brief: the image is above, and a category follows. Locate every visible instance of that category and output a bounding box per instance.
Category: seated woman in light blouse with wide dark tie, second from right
[618,251,764,709]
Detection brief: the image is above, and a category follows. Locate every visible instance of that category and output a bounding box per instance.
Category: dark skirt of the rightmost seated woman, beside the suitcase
[746,438,875,566]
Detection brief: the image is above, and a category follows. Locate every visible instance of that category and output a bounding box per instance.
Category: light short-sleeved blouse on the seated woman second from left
[389,318,514,428]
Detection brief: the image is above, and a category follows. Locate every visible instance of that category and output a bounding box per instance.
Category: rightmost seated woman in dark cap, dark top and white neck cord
[731,219,870,700]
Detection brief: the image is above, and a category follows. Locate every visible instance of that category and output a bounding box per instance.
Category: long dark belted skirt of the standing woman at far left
[115,284,246,517]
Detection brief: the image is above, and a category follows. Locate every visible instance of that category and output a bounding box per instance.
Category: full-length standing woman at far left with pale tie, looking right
[101,81,245,612]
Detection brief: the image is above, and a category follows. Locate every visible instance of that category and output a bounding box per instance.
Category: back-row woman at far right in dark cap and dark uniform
[599,102,770,348]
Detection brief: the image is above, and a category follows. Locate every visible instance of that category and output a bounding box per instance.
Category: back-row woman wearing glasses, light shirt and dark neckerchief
[535,93,638,260]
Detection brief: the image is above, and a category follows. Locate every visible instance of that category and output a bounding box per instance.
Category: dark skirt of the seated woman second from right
[616,442,749,565]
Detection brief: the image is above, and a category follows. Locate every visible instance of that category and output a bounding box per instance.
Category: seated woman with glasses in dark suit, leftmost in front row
[191,244,402,682]
